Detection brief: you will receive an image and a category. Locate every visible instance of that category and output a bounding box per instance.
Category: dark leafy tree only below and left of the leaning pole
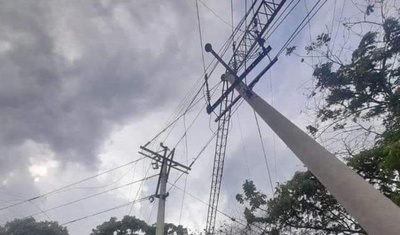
[238,171,364,234]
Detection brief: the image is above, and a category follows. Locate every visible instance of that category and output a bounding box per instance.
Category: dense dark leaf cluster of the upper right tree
[306,17,400,130]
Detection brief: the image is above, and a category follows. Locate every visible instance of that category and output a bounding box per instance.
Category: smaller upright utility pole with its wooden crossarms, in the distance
[139,143,190,235]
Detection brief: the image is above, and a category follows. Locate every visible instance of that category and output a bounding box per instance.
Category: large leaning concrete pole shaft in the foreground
[223,74,400,235]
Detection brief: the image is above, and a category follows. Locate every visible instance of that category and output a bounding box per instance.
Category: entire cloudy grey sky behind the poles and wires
[0,0,396,235]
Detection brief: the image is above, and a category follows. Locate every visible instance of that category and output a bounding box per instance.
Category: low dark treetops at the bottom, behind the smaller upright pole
[91,215,188,235]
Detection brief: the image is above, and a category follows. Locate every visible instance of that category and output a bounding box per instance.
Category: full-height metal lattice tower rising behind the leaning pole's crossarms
[205,0,286,235]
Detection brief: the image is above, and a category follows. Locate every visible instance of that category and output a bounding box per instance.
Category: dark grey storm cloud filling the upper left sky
[0,1,199,170]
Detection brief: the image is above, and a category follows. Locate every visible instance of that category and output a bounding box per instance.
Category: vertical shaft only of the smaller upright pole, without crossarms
[156,158,168,235]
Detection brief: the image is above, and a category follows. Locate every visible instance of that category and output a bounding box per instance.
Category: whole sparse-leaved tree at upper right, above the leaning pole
[287,0,400,157]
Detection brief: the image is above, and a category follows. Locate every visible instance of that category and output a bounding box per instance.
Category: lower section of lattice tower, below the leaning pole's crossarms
[206,81,232,234]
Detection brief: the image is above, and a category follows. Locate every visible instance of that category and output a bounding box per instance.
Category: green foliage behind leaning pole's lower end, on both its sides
[236,125,400,234]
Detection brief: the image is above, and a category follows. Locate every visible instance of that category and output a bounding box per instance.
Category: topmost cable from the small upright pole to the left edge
[0,157,146,211]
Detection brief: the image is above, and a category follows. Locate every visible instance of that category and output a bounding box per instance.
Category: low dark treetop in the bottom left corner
[0,218,69,235]
